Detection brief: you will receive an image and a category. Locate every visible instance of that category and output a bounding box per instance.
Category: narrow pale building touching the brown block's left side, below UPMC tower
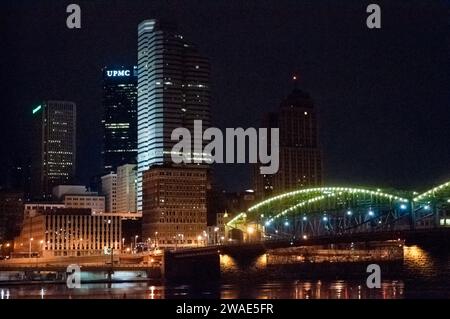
[116,164,137,213]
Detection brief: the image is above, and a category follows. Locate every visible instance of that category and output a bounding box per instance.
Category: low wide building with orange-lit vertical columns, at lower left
[14,208,122,257]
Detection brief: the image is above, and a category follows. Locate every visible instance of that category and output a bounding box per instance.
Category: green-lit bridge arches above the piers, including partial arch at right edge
[227,181,450,242]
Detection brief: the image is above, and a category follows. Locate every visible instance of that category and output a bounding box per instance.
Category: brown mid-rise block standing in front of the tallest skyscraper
[142,166,208,248]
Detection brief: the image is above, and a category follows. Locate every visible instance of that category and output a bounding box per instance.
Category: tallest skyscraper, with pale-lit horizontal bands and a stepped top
[137,20,210,211]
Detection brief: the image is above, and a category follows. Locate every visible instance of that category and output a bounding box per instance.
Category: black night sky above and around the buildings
[0,0,450,190]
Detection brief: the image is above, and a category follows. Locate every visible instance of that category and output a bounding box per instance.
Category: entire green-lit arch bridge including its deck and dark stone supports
[160,181,450,278]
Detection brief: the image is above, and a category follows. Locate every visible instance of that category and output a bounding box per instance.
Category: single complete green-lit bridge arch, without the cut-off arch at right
[228,187,414,239]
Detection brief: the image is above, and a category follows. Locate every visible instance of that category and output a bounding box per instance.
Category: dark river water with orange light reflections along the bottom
[0,246,450,299]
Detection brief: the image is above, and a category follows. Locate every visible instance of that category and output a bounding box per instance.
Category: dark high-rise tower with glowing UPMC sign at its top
[102,67,137,173]
